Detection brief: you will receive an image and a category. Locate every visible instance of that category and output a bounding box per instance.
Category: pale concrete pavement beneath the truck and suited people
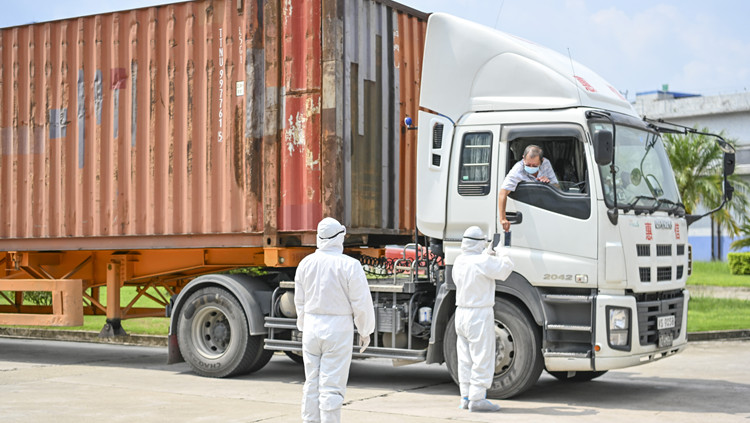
[0,338,750,423]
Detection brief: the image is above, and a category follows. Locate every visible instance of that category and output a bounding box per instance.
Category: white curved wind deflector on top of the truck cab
[420,13,637,121]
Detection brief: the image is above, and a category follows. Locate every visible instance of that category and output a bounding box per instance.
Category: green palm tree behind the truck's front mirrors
[664,128,750,237]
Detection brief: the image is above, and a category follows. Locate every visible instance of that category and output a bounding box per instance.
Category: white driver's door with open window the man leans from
[498,124,598,287]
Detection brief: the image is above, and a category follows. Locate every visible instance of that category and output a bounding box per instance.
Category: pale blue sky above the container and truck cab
[0,0,750,100]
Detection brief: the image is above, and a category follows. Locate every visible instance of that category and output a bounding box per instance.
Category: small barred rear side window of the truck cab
[458,132,492,195]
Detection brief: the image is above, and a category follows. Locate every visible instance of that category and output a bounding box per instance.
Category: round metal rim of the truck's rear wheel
[191,306,232,359]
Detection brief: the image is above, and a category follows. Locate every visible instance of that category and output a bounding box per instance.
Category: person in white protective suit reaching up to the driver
[452,226,513,411]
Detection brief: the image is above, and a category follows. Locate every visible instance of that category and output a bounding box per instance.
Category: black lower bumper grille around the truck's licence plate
[636,291,685,345]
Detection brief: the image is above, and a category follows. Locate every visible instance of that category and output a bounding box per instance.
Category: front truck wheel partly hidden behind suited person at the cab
[443,298,544,399]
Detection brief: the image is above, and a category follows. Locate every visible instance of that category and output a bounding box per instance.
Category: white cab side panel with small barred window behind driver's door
[446,125,505,240]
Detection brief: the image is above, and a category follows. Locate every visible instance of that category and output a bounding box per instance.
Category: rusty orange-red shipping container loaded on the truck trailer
[0,0,426,251]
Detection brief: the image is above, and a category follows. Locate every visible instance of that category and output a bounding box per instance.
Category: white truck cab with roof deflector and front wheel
[417,13,690,397]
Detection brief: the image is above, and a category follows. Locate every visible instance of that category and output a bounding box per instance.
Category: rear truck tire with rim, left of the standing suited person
[177,287,273,377]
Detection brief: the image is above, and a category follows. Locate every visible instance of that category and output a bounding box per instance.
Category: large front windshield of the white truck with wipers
[591,122,684,214]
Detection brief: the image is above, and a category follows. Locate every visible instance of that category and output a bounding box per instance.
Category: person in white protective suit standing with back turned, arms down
[294,217,375,423]
